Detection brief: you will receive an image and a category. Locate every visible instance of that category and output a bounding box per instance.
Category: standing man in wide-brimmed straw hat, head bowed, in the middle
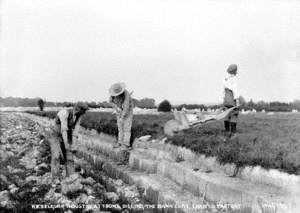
[109,82,134,148]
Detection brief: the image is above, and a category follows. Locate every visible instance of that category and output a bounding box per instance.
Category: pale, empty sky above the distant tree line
[0,0,300,103]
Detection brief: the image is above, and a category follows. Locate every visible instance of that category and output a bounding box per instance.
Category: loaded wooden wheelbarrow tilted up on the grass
[164,106,238,137]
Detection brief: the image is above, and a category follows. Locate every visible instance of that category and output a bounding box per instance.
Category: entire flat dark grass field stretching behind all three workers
[25,111,300,174]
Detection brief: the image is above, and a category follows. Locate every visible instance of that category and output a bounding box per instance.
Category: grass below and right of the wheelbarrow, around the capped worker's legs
[171,114,300,174]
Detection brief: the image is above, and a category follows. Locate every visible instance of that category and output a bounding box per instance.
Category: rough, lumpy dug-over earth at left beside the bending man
[0,113,119,213]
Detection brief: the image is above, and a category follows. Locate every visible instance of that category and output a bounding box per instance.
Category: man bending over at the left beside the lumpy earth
[51,102,88,176]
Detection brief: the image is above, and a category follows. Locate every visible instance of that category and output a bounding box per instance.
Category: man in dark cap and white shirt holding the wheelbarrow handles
[223,64,239,134]
